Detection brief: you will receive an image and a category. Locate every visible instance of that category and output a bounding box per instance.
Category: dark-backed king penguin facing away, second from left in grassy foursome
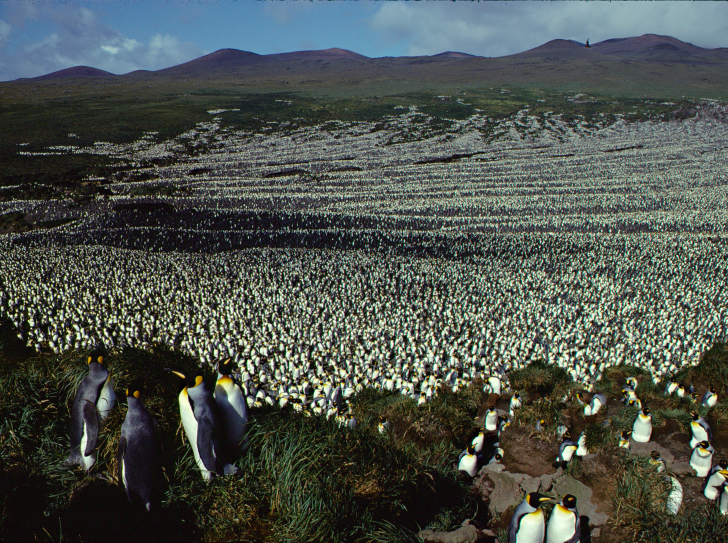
[117,379,162,511]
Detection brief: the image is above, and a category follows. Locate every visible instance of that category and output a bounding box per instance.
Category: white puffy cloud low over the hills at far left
[0,5,204,80]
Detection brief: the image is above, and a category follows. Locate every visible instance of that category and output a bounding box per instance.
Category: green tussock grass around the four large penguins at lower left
[0,346,479,541]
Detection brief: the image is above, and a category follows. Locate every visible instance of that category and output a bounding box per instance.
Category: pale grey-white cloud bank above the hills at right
[370,2,728,56]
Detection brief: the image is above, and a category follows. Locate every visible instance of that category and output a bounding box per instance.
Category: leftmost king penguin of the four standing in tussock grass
[66,347,116,471]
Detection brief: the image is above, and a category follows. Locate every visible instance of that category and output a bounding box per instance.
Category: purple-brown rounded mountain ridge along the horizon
[18,34,728,80]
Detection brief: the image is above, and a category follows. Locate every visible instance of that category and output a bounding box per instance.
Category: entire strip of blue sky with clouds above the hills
[0,0,728,81]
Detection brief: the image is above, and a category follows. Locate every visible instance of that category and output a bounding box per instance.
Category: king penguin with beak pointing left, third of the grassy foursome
[170,370,236,480]
